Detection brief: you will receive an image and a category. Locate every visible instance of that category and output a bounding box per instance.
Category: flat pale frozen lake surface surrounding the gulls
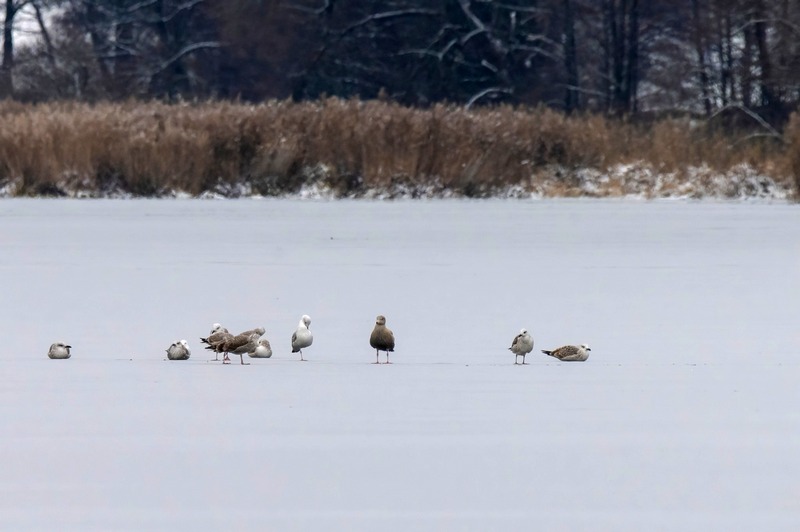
[0,200,800,531]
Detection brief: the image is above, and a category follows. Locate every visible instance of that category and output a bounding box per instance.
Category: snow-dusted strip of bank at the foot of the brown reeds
[0,161,797,201]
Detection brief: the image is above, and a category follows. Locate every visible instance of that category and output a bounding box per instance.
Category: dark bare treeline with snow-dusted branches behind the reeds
[0,0,800,125]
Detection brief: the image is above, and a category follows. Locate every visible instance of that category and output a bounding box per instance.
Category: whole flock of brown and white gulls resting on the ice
[47,314,591,365]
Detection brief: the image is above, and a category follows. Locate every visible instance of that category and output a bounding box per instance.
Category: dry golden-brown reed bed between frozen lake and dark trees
[0,99,800,197]
